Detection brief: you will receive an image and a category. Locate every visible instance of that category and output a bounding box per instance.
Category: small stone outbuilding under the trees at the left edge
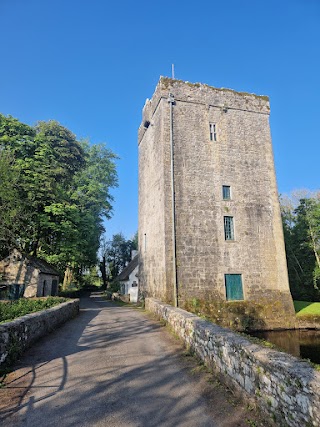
[0,249,59,298]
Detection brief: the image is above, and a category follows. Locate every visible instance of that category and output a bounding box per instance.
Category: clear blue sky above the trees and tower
[0,0,320,241]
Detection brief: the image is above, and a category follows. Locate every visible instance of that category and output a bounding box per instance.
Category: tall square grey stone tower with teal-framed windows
[138,77,294,329]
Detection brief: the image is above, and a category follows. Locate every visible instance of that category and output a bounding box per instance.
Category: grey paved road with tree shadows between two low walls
[0,295,264,427]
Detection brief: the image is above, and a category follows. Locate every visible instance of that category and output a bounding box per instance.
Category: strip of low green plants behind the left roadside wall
[0,297,67,323]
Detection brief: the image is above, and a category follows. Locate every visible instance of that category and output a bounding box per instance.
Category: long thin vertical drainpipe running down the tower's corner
[168,93,179,307]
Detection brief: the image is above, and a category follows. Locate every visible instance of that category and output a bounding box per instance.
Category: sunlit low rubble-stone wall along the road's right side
[145,298,320,427]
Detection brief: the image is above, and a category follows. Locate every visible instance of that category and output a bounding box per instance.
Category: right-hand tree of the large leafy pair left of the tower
[45,141,117,287]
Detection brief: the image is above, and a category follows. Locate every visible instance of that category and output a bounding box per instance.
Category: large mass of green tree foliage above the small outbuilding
[0,115,117,288]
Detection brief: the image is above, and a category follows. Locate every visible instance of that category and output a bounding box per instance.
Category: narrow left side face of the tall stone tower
[138,98,172,301]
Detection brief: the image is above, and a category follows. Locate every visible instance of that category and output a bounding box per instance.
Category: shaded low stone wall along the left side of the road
[0,299,79,370]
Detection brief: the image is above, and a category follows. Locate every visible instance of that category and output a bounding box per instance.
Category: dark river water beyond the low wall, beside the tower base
[250,329,320,364]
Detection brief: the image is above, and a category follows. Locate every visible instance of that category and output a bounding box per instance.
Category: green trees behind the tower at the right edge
[280,190,320,301]
